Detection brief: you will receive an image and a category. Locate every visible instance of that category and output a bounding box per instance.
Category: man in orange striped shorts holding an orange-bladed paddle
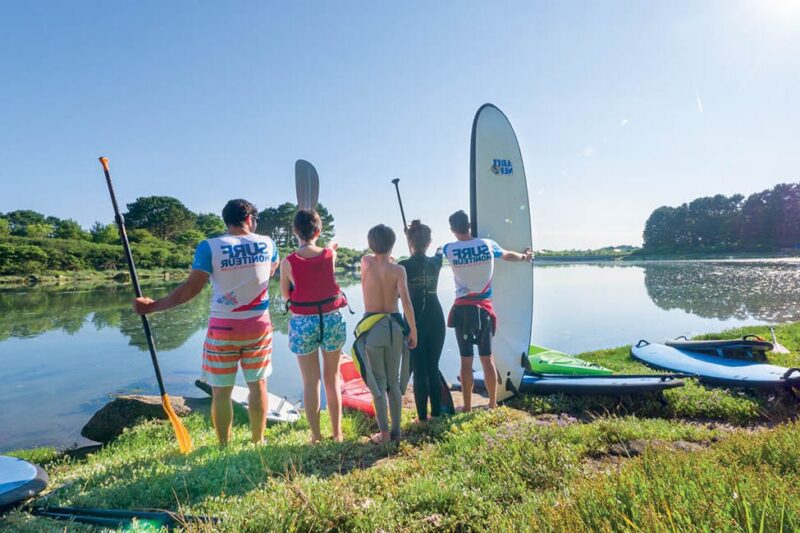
[134,200,279,445]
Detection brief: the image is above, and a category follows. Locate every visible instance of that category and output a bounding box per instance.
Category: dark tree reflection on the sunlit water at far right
[644,262,800,322]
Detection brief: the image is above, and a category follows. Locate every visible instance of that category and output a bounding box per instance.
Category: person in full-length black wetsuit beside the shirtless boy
[399,220,446,422]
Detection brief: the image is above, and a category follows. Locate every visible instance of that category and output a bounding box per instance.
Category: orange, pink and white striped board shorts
[203,313,272,387]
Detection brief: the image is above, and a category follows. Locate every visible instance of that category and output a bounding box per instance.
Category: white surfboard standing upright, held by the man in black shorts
[470,104,533,400]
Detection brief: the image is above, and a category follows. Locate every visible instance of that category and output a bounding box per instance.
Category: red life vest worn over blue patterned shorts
[286,248,347,315]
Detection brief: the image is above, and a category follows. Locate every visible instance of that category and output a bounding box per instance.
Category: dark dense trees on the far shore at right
[643,183,800,253]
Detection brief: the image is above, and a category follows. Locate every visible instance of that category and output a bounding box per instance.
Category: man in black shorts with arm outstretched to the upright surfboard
[444,211,533,411]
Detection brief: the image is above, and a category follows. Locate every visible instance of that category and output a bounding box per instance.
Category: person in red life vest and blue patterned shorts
[281,210,347,443]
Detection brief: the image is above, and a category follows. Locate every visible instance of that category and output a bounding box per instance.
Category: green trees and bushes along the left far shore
[0,196,362,275]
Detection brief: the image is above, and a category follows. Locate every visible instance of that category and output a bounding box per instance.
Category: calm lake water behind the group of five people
[0,259,800,451]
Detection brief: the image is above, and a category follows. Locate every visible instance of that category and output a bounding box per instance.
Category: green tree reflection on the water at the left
[0,276,360,344]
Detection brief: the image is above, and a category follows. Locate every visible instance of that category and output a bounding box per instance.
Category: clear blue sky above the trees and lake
[0,0,800,248]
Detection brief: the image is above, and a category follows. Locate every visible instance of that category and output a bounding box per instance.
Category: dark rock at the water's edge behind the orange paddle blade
[81,395,191,443]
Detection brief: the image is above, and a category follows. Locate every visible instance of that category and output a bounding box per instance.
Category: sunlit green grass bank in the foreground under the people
[0,324,800,531]
